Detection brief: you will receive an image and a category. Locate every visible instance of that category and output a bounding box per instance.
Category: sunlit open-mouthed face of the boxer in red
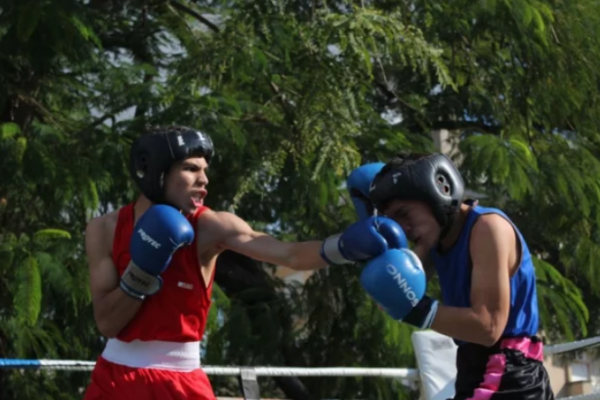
[165,157,208,214]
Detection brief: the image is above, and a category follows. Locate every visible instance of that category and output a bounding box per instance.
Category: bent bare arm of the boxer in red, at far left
[85,217,142,338]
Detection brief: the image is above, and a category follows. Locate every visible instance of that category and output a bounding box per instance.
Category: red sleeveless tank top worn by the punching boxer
[112,203,214,343]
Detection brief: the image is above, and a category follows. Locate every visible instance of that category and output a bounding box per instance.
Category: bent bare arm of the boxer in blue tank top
[431,215,519,346]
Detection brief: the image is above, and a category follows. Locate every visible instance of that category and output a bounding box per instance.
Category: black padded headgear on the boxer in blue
[369,154,465,236]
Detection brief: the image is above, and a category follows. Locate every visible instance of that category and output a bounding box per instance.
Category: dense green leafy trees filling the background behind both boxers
[0,0,600,399]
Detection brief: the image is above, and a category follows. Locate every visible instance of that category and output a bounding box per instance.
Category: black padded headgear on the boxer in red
[129,126,214,204]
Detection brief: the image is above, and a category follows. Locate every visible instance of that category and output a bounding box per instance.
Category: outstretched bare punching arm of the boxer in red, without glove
[198,211,327,270]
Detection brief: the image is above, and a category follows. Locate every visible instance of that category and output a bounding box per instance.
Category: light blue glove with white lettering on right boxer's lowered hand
[360,248,439,329]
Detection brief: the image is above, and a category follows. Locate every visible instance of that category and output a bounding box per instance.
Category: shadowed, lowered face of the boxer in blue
[383,200,440,251]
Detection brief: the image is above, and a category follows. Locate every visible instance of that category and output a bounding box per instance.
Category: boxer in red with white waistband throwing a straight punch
[85,127,401,400]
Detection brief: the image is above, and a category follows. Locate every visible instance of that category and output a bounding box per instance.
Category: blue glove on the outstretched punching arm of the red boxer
[321,217,408,265]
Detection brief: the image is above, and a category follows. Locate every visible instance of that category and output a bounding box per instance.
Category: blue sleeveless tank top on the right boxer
[431,206,539,343]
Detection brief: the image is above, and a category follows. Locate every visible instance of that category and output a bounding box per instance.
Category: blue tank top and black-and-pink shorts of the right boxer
[431,206,553,400]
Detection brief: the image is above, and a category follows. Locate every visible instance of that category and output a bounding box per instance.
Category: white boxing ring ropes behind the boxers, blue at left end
[0,337,600,400]
